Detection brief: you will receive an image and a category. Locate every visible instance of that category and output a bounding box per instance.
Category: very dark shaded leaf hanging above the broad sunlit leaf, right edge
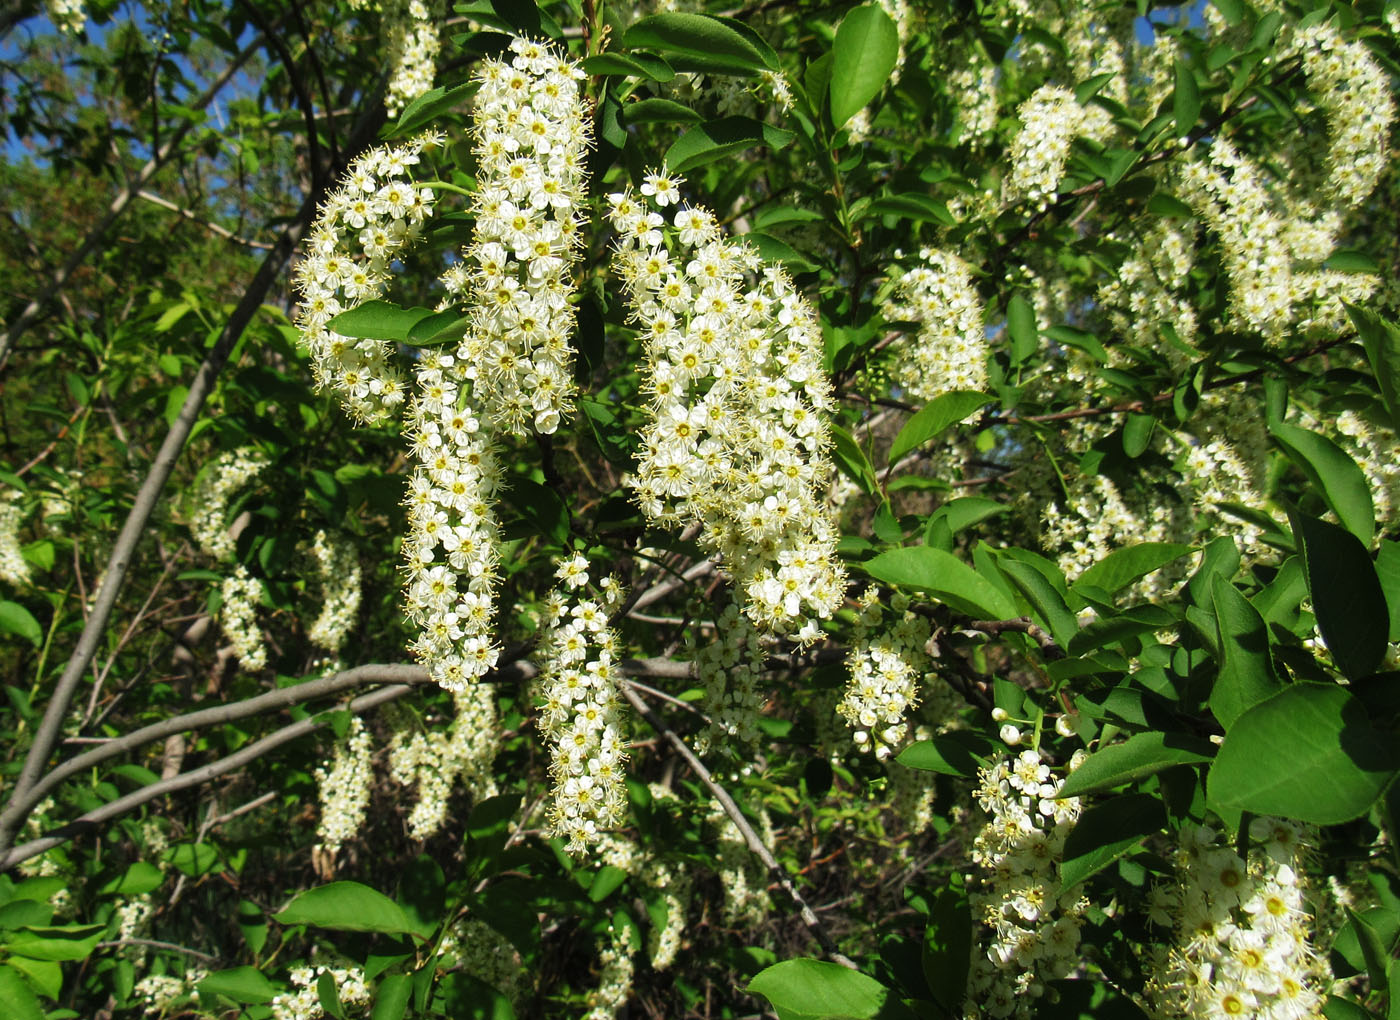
[1291,513,1390,680]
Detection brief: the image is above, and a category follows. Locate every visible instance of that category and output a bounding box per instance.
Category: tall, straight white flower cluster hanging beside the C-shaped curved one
[442,39,589,434]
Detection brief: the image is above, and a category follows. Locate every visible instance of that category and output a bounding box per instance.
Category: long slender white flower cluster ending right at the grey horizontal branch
[403,350,503,691]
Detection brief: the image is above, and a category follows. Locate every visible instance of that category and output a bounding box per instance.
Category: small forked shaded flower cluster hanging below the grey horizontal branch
[389,684,501,840]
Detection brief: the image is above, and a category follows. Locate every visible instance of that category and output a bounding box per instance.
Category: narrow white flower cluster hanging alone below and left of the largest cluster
[539,557,627,852]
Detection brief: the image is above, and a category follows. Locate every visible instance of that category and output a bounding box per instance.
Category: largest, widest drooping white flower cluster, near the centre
[609,173,844,639]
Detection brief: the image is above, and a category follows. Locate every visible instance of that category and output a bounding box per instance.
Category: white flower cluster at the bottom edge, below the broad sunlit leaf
[1147,817,1331,1020]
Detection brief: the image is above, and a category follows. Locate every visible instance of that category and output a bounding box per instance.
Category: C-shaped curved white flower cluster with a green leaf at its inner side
[297,134,438,421]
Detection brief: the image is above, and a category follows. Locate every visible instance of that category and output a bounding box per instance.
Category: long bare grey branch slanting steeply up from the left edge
[0,105,384,851]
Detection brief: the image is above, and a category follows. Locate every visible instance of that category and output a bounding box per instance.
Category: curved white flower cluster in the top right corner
[1295,22,1396,207]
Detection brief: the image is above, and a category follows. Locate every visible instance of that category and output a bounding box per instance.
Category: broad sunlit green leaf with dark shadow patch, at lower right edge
[1207,683,1400,826]
